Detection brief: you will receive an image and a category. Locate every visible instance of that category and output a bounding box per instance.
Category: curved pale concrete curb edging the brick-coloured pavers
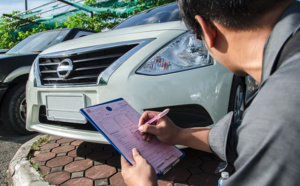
[7,135,49,186]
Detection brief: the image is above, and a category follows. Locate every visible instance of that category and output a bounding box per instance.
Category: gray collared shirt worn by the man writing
[209,2,300,186]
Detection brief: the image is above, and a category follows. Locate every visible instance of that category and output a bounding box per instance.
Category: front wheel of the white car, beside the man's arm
[228,76,245,122]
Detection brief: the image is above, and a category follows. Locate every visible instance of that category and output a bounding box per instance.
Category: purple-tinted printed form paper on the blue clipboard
[83,99,183,174]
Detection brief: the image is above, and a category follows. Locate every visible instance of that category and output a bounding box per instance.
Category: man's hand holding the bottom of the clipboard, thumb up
[121,148,157,186]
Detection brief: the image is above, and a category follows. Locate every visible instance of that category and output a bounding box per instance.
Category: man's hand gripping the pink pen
[139,111,182,145]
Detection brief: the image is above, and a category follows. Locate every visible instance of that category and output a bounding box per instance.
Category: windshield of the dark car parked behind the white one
[7,30,69,54]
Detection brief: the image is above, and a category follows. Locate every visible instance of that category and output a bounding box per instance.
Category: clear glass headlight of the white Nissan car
[137,32,213,75]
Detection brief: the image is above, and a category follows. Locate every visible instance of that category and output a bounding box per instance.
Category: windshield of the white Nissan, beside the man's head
[114,3,179,29]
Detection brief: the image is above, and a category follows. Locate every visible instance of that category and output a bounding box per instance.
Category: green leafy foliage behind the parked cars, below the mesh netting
[0,0,175,49]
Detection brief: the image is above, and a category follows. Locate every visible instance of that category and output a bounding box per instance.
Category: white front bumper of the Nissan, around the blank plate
[26,63,232,143]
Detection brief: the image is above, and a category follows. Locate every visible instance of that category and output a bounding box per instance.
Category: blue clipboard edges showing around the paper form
[80,98,185,178]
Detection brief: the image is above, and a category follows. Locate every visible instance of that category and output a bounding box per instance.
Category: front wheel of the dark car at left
[1,84,32,135]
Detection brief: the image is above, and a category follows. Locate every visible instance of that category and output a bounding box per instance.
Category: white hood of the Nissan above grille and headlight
[41,21,187,54]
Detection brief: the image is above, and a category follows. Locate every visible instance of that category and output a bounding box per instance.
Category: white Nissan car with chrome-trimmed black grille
[26,3,245,143]
